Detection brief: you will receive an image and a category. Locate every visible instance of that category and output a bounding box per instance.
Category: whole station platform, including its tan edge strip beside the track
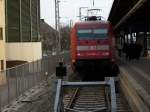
[117,57,150,112]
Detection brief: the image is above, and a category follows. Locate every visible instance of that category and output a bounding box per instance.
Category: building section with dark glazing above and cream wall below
[5,0,42,65]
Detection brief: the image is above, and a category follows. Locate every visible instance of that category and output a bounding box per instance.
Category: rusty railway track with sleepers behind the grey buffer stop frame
[63,86,132,112]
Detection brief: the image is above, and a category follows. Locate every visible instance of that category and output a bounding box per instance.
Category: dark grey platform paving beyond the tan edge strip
[119,57,150,95]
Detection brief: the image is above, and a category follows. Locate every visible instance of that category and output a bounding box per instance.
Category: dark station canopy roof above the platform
[108,0,150,32]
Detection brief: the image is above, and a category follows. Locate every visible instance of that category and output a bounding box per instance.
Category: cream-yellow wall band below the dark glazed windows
[6,42,42,62]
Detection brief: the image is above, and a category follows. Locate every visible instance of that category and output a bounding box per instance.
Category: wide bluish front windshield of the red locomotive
[77,28,108,39]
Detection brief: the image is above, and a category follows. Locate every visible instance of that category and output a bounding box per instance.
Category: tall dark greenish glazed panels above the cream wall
[6,0,40,42]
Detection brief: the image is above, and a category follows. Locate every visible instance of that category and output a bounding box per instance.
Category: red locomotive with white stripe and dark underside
[71,16,118,78]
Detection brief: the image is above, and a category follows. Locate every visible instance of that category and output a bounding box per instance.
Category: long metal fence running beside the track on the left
[0,53,69,108]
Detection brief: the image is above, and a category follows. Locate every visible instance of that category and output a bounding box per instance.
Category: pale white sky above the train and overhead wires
[41,0,113,28]
